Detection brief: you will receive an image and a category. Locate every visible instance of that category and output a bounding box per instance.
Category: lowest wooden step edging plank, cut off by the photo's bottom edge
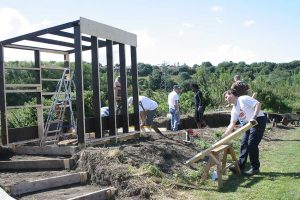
[68,187,117,200]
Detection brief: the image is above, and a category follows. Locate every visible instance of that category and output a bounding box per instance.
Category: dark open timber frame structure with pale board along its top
[0,17,140,145]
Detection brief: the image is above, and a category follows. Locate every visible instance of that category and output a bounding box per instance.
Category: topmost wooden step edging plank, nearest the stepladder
[13,146,78,156]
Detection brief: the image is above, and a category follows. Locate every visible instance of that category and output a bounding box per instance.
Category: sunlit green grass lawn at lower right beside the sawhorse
[166,128,300,200]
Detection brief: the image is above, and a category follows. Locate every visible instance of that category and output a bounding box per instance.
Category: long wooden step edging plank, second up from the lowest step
[9,172,88,196]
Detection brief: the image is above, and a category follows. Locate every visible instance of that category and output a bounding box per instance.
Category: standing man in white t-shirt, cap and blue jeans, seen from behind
[168,85,180,131]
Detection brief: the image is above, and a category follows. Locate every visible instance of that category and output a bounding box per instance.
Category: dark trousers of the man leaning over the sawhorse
[239,116,267,170]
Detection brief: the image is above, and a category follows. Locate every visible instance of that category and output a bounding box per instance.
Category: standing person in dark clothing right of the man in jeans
[191,83,206,128]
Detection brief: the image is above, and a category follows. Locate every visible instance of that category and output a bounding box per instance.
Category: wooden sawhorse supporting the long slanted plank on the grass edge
[201,144,241,188]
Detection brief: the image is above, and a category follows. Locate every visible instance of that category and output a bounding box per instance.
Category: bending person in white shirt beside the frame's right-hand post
[128,96,158,126]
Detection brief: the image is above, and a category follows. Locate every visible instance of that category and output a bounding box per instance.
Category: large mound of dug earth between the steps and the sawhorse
[77,135,197,199]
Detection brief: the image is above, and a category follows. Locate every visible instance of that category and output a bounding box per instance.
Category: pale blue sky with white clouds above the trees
[0,0,300,66]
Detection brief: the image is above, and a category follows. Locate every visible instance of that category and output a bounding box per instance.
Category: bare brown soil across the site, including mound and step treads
[0,116,293,199]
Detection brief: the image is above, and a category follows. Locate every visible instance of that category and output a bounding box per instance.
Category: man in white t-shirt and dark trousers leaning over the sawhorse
[224,84,267,176]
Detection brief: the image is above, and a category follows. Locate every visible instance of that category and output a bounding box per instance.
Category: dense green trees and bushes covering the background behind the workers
[5,61,300,128]
